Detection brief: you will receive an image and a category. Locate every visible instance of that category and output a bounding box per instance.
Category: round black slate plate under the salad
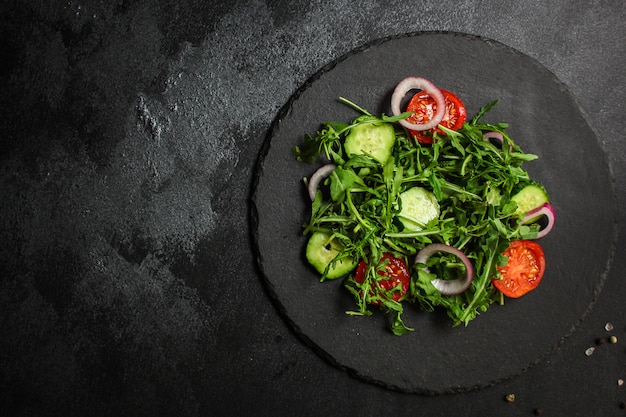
[252,32,616,393]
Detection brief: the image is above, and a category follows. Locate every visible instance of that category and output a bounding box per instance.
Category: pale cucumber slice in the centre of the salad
[398,187,439,231]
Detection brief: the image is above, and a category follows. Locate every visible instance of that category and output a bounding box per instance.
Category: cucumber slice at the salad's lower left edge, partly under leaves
[306,232,357,279]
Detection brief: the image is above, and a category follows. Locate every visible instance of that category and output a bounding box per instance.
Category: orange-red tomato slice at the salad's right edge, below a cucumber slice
[491,240,546,298]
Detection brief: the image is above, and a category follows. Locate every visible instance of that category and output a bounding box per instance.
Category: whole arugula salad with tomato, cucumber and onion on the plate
[293,77,555,335]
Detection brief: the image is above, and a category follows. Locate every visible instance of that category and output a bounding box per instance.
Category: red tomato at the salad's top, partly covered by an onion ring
[406,89,467,145]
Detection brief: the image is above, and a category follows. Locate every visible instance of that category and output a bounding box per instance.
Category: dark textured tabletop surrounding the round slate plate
[0,0,626,416]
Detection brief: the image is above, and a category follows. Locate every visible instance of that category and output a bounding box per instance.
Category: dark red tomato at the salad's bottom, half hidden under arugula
[354,253,411,305]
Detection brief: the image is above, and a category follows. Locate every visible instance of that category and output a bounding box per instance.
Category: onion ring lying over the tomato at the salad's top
[391,77,446,131]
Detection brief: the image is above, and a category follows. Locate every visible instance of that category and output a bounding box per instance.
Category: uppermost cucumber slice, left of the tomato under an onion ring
[344,123,396,164]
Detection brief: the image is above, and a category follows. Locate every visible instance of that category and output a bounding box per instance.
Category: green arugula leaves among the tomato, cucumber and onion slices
[293,98,538,335]
